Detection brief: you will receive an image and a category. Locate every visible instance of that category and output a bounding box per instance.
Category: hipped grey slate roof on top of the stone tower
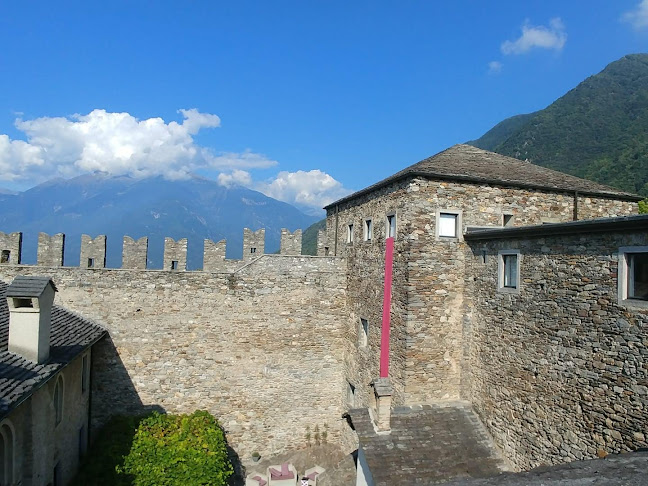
[326,144,642,208]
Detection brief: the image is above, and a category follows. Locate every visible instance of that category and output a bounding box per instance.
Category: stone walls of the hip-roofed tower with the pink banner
[327,178,637,404]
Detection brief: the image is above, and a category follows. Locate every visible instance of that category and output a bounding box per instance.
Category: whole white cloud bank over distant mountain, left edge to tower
[0,109,350,214]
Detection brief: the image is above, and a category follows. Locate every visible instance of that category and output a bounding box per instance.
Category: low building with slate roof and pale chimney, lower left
[0,276,105,486]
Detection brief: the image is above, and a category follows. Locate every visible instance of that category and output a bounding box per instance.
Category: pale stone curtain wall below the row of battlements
[0,255,348,463]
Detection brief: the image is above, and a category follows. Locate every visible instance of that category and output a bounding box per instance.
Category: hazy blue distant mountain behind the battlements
[0,175,318,269]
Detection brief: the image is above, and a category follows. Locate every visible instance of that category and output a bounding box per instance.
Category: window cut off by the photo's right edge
[618,246,648,308]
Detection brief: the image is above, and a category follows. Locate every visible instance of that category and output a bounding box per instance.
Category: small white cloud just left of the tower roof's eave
[254,169,351,214]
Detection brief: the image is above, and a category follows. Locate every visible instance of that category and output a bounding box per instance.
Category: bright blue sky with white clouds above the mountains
[0,0,648,213]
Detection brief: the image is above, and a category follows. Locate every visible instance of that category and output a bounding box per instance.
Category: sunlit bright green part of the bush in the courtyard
[122,410,233,486]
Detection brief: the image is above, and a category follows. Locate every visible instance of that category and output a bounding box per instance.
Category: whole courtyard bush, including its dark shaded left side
[72,411,233,486]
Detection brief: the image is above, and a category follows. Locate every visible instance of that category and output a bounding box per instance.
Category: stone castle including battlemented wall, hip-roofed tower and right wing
[0,145,648,484]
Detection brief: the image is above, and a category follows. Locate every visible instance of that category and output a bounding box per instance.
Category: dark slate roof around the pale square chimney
[0,282,106,419]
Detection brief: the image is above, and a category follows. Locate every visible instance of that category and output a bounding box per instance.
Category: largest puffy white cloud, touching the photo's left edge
[0,109,277,183]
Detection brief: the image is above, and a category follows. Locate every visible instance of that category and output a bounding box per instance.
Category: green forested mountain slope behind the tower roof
[468,54,648,196]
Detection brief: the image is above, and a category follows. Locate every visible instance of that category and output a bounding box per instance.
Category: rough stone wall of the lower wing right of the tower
[466,231,648,469]
